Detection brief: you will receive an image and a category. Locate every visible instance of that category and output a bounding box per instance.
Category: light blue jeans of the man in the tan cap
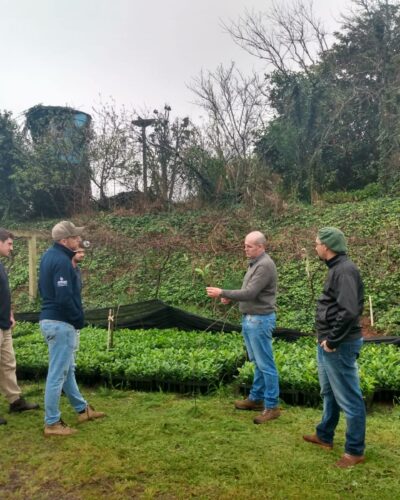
[40,319,87,425]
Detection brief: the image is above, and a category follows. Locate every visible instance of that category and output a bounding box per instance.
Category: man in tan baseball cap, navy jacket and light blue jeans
[39,221,105,436]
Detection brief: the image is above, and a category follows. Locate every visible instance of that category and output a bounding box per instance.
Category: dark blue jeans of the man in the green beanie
[316,339,366,455]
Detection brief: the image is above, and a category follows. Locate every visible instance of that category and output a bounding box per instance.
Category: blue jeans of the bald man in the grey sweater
[242,313,279,408]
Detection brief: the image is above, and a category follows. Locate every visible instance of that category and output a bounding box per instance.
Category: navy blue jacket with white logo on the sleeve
[39,243,84,329]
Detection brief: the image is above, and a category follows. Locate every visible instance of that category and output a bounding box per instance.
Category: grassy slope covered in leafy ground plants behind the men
[6,198,400,334]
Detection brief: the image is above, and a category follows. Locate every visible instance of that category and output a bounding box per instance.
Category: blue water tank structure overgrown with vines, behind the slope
[25,104,92,216]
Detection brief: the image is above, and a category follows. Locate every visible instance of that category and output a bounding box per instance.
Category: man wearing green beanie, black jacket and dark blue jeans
[303,227,366,468]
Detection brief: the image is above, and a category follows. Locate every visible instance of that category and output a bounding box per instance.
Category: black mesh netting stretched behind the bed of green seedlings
[15,300,400,347]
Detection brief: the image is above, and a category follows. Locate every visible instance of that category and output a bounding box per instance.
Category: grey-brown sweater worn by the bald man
[221,253,278,314]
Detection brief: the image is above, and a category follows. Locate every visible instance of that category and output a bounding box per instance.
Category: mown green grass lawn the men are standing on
[0,382,400,500]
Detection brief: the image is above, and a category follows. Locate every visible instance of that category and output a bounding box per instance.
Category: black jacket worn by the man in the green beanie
[316,255,364,349]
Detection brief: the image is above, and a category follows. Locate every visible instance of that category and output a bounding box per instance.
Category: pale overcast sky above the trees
[0,0,351,121]
